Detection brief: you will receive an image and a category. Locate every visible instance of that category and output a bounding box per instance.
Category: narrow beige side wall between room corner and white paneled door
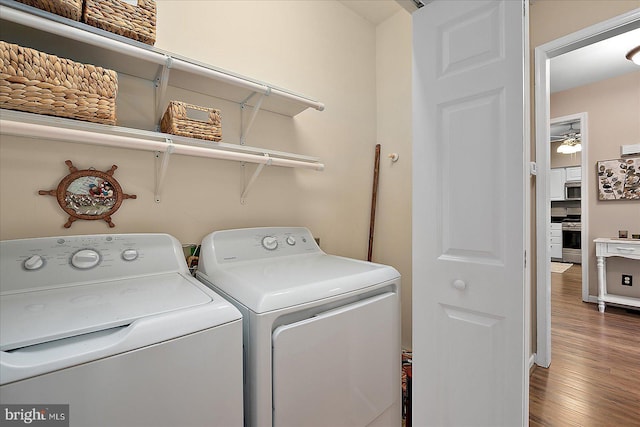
[373,10,412,348]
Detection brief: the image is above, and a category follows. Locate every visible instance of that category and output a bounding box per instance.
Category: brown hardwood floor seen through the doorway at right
[529,265,640,427]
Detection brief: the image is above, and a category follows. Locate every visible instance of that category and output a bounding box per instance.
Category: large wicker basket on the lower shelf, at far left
[0,41,118,125]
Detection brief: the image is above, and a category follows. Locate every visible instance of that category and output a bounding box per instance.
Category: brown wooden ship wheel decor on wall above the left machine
[38,160,136,228]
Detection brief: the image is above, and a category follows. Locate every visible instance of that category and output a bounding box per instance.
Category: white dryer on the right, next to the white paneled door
[196,227,402,427]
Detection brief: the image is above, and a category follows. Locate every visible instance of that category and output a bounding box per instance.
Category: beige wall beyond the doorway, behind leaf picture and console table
[551,71,640,297]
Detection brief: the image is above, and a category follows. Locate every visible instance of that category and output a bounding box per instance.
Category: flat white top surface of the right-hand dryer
[198,253,400,313]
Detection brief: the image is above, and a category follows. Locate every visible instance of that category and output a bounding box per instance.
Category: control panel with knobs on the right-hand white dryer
[202,227,322,264]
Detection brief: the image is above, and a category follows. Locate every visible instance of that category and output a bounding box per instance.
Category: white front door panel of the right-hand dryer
[272,292,401,427]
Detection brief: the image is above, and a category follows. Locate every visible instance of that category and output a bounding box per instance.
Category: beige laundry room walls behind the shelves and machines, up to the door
[0,0,411,347]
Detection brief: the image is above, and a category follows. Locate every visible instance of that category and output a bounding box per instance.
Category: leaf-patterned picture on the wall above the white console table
[596,157,640,200]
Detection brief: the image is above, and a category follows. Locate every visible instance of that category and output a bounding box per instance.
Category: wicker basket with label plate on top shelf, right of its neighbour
[82,0,156,46]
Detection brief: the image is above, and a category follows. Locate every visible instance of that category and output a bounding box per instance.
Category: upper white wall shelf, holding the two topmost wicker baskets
[0,0,324,117]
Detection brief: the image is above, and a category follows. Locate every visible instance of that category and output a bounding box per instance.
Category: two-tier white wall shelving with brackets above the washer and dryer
[0,0,324,203]
